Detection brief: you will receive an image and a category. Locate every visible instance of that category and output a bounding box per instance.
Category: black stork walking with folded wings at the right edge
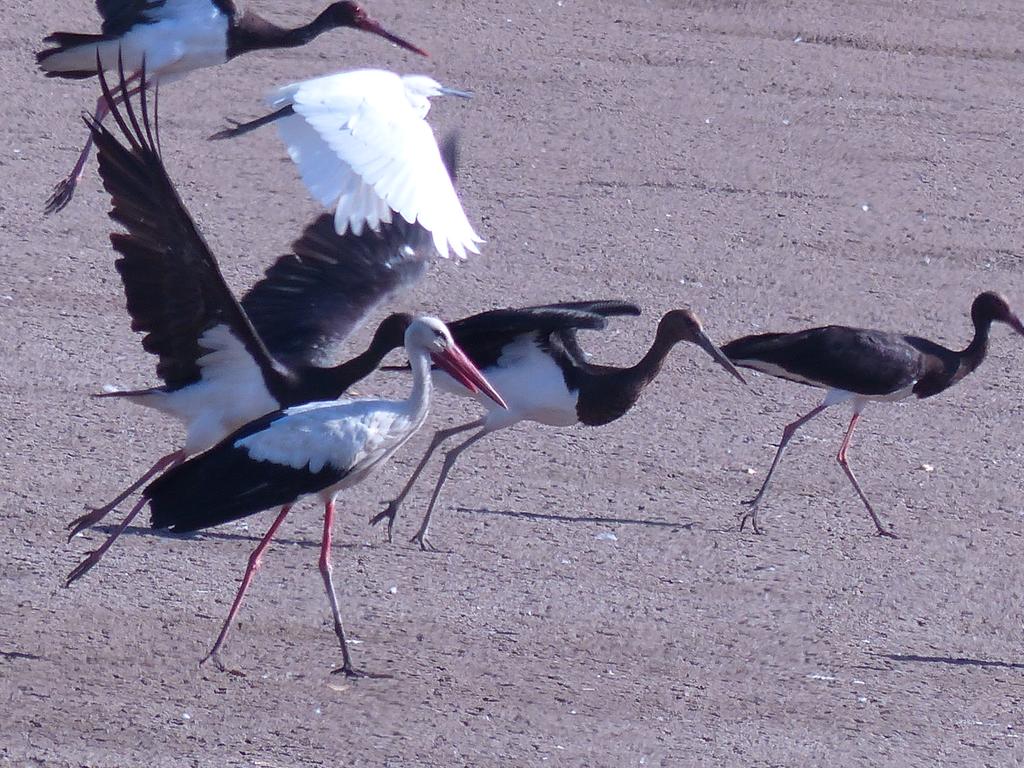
[722,292,1024,537]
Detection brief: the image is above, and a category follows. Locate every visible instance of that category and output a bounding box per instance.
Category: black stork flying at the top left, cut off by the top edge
[36,0,427,213]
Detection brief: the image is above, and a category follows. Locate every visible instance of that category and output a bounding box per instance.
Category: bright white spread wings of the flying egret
[270,70,482,258]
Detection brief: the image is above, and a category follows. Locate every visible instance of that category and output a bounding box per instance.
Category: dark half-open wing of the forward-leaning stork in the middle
[449,301,640,368]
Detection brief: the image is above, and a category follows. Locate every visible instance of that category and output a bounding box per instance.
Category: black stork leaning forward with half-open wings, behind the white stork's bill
[371,301,743,549]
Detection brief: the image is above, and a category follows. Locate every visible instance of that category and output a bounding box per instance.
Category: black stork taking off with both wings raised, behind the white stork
[68,64,444,584]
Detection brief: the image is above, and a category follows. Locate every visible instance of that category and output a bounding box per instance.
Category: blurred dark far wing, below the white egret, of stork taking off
[242,213,433,366]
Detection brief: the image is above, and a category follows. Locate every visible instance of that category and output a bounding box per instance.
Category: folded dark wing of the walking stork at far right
[722,326,922,395]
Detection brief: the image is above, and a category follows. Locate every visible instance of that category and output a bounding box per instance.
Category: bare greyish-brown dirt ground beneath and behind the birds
[0,0,1024,768]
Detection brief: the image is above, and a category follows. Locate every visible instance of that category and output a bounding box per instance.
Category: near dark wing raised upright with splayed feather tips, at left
[88,61,278,391]
